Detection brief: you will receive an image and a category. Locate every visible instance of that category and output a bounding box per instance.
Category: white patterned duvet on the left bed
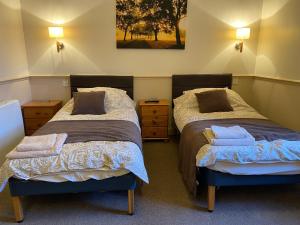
[0,95,149,191]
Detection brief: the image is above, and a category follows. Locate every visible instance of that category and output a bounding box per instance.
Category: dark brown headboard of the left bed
[70,75,133,99]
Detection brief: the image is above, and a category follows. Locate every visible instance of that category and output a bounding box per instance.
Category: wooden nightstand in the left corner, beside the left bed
[22,100,62,136]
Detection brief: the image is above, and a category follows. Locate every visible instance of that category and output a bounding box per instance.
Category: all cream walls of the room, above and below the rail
[0,0,300,130]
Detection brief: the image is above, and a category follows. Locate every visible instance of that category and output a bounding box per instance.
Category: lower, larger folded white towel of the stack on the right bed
[203,128,255,146]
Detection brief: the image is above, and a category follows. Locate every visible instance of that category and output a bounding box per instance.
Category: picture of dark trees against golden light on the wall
[116,0,187,49]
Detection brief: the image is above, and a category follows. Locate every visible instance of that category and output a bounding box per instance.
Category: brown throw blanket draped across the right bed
[179,119,300,194]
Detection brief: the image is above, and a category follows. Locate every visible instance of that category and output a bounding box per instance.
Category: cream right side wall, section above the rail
[256,0,300,80]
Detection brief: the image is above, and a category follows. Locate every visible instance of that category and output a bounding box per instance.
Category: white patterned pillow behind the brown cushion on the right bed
[174,88,249,109]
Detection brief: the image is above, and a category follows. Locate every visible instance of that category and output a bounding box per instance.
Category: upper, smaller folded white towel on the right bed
[211,126,247,139]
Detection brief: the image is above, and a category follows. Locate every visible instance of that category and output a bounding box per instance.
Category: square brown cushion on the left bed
[72,91,106,115]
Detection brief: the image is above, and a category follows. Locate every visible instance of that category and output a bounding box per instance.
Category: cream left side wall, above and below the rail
[0,0,31,103]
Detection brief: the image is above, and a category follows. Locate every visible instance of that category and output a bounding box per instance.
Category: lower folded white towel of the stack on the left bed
[6,133,68,159]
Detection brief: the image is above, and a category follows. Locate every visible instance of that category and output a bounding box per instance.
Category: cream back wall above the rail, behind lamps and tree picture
[21,0,262,76]
